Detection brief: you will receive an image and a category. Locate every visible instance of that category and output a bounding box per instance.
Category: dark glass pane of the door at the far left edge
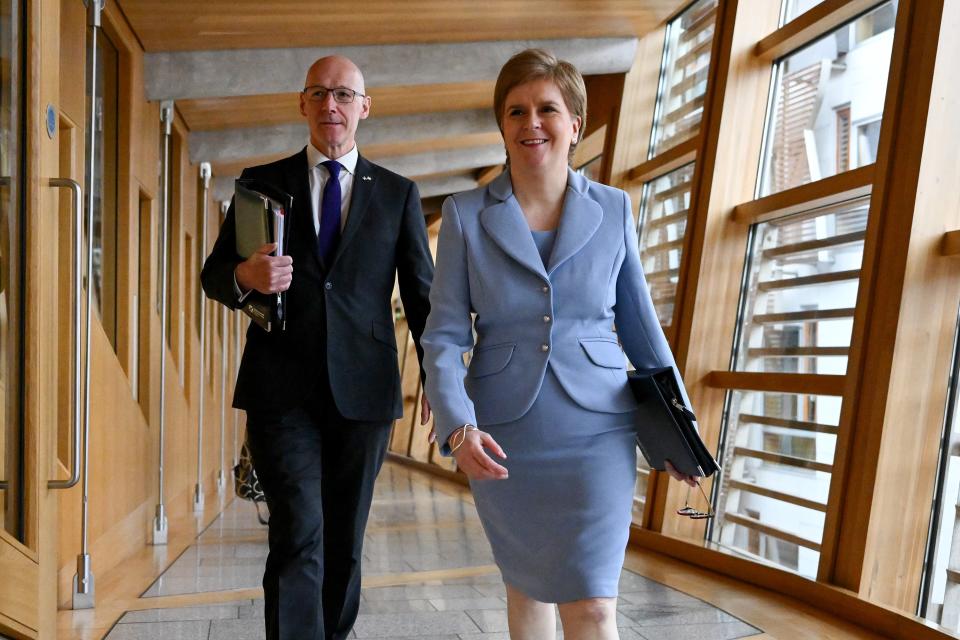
[0,0,24,541]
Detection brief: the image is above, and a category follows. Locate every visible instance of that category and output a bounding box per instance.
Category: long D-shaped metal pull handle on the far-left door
[47,178,83,489]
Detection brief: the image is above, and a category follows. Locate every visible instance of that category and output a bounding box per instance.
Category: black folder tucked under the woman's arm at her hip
[627,367,720,477]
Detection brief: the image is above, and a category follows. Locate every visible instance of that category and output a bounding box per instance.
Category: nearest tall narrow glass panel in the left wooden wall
[87,26,120,350]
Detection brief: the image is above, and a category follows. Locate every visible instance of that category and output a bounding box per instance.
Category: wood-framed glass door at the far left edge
[0,0,71,638]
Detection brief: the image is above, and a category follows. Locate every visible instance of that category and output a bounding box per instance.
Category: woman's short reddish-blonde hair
[493,49,587,162]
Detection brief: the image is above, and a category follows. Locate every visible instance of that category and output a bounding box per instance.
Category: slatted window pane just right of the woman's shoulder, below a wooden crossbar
[637,163,694,327]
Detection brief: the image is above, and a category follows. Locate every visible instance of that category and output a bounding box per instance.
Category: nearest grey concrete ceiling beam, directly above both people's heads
[144,37,637,100]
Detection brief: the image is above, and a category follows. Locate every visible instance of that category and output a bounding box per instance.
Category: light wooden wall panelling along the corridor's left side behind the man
[57,0,234,603]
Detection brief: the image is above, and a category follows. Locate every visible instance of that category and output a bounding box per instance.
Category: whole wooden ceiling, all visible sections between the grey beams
[120,0,689,199]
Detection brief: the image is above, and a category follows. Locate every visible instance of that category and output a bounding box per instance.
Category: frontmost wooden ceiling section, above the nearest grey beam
[118,0,686,51]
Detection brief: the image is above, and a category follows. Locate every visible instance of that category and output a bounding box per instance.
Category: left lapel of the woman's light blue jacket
[480,170,547,279]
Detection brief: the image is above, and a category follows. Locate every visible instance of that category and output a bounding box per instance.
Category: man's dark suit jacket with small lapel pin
[200,148,433,422]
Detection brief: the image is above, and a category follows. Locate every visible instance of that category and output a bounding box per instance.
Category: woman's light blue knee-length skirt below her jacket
[470,368,637,603]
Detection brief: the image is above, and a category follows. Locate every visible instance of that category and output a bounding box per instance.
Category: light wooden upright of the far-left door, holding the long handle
[34,0,66,638]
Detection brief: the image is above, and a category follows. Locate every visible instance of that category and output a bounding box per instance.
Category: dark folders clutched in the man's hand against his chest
[234,179,293,331]
